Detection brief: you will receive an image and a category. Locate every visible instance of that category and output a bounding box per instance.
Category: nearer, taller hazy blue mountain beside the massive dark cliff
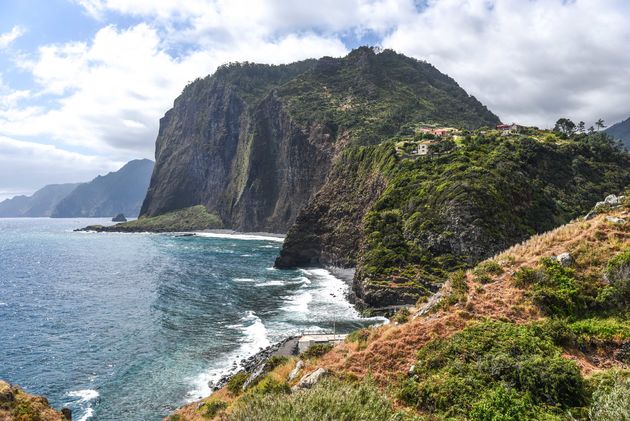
[51,159,153,218]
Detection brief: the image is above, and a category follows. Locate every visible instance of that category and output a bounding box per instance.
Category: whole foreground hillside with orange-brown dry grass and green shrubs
[170,193,630,421]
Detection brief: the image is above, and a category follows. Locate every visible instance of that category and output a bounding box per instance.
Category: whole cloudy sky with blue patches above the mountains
[0,0,630,200]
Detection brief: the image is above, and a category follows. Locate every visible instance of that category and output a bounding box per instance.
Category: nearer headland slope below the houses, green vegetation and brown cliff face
[276,129,630,307]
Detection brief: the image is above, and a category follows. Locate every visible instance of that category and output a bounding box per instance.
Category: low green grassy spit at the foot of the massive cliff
[83,205,222,232]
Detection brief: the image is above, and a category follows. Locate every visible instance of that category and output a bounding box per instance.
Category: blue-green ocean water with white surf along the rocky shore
[0,218,379,421]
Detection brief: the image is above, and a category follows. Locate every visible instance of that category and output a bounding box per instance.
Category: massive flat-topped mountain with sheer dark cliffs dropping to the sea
[141,47,498,232]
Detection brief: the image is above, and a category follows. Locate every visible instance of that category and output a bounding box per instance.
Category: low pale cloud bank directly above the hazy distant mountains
[0,136,124,200]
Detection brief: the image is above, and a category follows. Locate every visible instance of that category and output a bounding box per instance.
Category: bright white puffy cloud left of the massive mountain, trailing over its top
[0,23,346,159]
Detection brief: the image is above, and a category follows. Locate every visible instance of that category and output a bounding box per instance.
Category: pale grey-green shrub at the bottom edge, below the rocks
[229,379,403,421]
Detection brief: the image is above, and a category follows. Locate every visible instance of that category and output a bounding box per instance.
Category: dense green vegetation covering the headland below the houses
[356,131,630,304]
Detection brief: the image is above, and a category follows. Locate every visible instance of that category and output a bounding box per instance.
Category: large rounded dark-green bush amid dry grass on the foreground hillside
[400,321,587,420]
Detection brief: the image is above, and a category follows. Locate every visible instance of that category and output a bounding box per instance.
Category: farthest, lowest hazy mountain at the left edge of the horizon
[0,183,80,218]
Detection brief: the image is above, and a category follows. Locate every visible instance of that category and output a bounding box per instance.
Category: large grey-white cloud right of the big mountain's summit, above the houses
[383,0,630,126]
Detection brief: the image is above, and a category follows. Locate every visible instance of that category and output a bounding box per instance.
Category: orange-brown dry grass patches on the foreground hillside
[170,203,630,420]
